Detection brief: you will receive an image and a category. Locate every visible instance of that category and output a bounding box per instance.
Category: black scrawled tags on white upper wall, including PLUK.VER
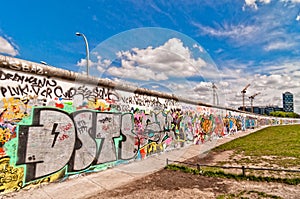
[0,70,119,105]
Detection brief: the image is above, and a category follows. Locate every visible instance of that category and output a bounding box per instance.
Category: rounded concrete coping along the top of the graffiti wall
[0,55,296,118]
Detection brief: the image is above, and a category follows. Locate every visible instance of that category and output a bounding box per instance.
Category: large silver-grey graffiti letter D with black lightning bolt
[16,108,76,181]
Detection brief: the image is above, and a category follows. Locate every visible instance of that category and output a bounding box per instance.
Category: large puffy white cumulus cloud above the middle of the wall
[102,38,208,81]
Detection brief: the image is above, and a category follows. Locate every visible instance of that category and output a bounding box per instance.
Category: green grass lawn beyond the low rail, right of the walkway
[213,125,300,167]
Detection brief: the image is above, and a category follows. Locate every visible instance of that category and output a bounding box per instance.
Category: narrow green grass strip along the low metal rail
[165,164,300,185]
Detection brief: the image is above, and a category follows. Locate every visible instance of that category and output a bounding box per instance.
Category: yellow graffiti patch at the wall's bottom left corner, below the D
[0,157,24,192]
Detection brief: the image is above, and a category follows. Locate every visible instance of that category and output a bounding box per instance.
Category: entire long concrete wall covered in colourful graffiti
[0,56,298,193]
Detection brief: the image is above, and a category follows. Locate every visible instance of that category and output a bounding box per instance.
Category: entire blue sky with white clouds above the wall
[0,0,300,113]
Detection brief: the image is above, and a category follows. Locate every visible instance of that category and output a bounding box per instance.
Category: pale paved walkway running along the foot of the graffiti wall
[0,129,258,199]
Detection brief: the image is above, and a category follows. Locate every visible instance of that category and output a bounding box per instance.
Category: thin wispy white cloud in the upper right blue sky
[192,1,300,52]
